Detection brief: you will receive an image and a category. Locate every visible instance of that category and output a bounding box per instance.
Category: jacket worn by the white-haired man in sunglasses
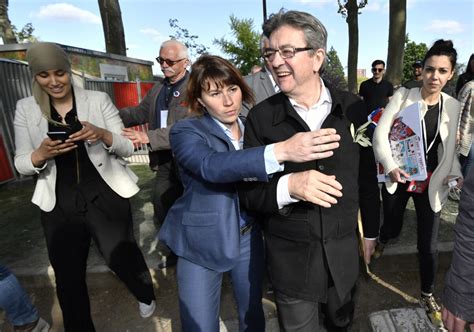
[120,73,189,170]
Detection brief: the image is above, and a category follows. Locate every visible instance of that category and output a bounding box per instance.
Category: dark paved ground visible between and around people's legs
[0,166,457,332]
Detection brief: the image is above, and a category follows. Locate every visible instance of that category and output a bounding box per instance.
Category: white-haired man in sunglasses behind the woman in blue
[120,39,190,268]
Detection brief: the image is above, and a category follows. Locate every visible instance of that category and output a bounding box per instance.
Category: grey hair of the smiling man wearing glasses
[263,9,328,51]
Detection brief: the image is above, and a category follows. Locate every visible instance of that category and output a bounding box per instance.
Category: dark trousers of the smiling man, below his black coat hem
[275,286,354,332]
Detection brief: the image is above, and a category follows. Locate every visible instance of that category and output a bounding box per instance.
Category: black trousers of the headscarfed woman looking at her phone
[41,182,155,332]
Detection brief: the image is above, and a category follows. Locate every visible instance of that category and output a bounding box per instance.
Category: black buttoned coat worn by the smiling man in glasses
[241,84,379,302]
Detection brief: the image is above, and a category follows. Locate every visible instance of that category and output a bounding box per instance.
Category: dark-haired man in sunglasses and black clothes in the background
[359,60,393,115]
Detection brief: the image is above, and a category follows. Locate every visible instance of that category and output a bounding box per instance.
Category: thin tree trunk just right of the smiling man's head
[345,0,359,93]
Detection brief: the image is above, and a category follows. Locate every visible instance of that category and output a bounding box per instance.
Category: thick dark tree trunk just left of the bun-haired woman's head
[385,0,407,87]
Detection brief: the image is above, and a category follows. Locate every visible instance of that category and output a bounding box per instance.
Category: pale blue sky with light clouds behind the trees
[9,0,474,73]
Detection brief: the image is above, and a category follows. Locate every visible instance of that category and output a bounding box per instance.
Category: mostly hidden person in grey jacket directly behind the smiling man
[240,35,280,116]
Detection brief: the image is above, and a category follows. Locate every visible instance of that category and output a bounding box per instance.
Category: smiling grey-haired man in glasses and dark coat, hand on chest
[241,11,379,331]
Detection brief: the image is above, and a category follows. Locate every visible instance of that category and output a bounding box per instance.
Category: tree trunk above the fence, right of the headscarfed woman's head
[99,0,127,55]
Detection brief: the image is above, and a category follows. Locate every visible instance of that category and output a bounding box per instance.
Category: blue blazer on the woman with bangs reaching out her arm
[159,115,268,272]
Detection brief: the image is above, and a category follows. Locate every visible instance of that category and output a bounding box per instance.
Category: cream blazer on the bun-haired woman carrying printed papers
[373,88,462,212]
